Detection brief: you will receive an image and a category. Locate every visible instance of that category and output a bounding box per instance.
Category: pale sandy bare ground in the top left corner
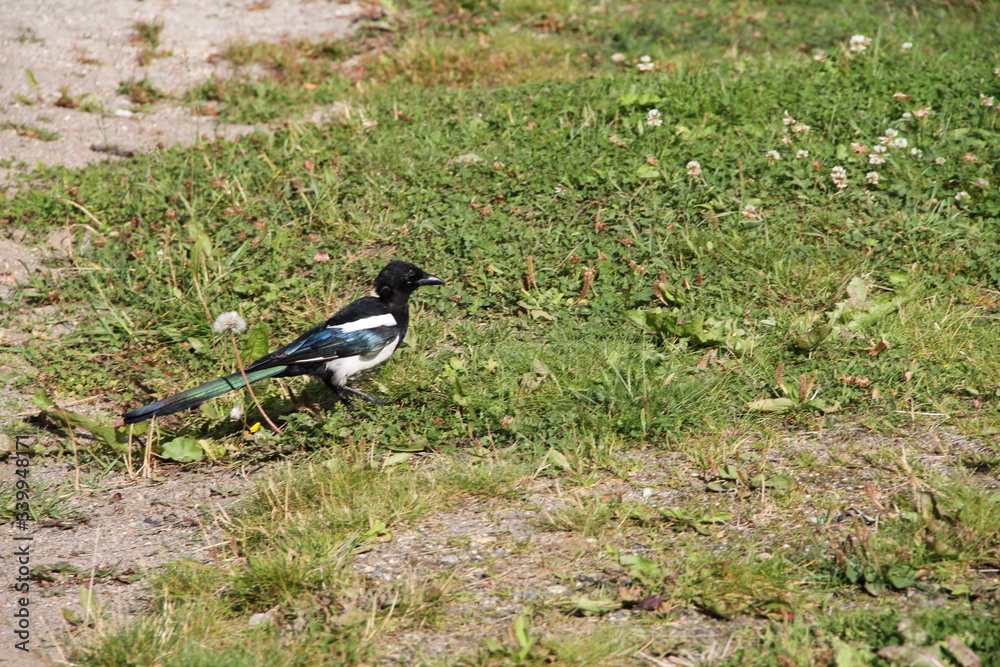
[0,0,361,190]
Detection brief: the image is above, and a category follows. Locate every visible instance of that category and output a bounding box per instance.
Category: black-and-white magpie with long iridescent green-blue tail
[122,260,445,424]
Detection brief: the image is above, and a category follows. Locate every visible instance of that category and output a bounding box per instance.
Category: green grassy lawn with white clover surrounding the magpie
[0,0,1000,667]
